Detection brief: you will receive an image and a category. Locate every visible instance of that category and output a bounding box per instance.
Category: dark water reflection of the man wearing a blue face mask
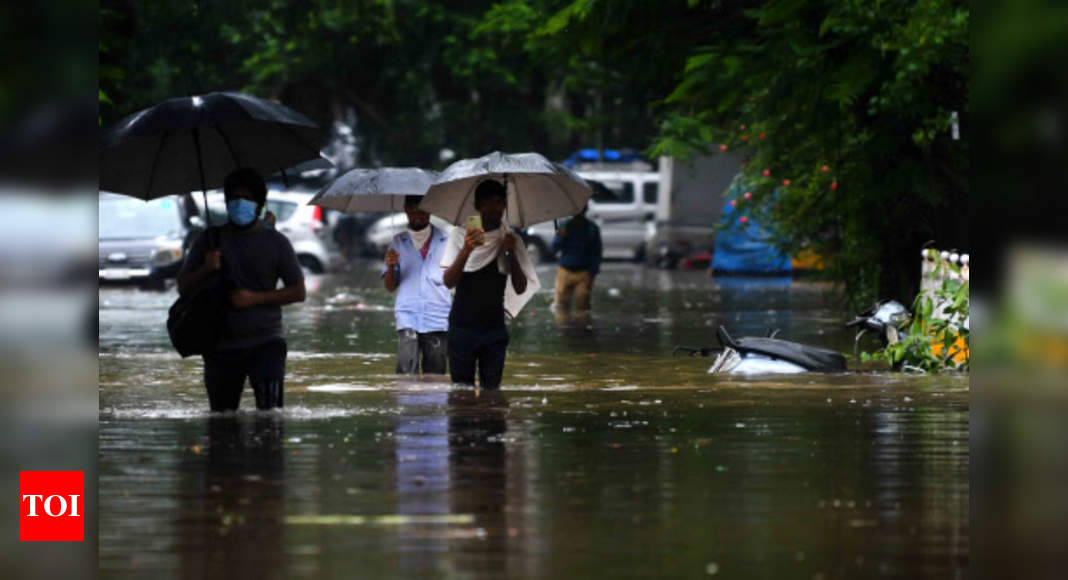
[177,413,286,578]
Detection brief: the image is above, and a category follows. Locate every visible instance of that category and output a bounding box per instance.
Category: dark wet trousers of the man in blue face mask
[204,339,286,411]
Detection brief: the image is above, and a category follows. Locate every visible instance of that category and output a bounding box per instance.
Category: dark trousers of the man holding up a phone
[449,326,508,389]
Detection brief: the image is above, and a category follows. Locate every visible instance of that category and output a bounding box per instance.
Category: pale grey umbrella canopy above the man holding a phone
[419,152,593,228]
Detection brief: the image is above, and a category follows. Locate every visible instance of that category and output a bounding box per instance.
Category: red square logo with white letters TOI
[18,471,85,542]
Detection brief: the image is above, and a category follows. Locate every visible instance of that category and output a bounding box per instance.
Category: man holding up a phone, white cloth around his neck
[441,179,540,389]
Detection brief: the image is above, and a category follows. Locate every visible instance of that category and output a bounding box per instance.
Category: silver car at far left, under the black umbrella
[97,191,201,289]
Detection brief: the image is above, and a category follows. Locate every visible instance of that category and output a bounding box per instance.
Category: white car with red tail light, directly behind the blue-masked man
[194,190,345,273]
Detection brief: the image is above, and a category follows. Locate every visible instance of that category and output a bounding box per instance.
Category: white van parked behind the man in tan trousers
[525,171,660,263]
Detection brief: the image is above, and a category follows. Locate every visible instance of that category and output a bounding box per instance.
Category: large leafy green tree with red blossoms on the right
[545,0,970,304]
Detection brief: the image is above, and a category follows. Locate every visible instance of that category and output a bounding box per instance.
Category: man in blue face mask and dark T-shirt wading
[178,168,304,411]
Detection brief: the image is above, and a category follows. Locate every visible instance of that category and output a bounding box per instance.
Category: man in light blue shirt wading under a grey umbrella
[382,195,453,375]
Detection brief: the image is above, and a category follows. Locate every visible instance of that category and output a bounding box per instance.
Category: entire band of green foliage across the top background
[99,0,970,305]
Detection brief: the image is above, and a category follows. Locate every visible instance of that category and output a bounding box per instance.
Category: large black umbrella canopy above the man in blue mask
[99,92,320,200]
